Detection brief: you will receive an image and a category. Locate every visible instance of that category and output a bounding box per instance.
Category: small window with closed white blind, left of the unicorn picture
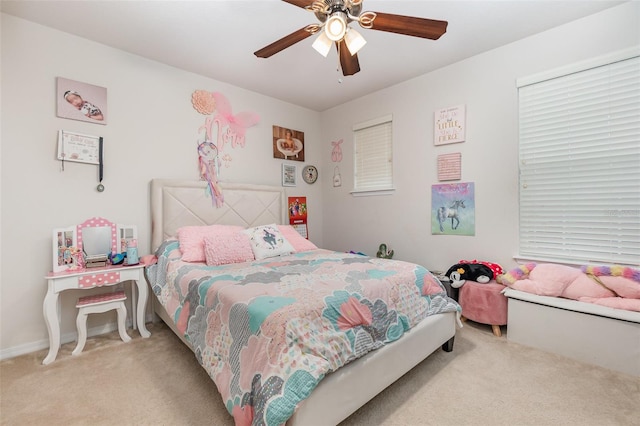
[352,115,393,195]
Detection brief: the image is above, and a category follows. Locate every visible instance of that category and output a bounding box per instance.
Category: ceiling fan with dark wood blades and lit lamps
[254,0,448,76]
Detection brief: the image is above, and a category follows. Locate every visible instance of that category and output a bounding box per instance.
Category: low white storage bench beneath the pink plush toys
[505,288,640,377]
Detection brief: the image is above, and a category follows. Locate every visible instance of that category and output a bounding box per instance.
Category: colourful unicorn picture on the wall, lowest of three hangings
[431,182,476,235]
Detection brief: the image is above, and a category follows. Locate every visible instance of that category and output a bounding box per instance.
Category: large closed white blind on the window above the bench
[518,54,640,265]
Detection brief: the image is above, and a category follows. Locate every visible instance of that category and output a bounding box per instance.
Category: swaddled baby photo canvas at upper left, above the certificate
[56,77,107,124]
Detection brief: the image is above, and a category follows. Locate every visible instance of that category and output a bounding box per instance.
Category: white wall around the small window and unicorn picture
[322,2,640,270]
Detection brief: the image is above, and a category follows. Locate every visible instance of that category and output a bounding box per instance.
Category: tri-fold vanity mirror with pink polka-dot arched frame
[53,217,138,272]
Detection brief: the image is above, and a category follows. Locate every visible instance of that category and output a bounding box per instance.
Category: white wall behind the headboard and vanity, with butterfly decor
[0,14,323,356]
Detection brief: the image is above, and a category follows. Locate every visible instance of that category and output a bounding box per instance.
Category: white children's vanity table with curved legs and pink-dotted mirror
[42,217,151,365]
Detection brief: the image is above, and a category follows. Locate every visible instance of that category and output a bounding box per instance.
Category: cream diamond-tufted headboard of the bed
[151,179,287,251]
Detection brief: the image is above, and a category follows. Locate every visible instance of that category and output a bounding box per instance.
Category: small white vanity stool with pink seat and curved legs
[71,291,131,355]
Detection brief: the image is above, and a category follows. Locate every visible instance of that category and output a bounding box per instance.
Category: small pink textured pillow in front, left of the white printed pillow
[204,232,255,266]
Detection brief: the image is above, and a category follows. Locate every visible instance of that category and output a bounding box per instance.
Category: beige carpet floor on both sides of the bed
[0,322,640,426]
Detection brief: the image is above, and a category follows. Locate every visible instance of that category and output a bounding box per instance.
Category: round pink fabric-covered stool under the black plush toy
[458,280,507,337]
